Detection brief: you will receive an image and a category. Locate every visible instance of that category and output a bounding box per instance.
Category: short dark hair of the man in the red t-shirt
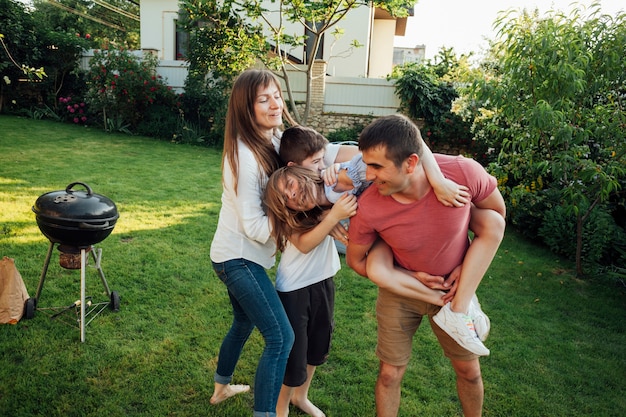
[359,114,422,167]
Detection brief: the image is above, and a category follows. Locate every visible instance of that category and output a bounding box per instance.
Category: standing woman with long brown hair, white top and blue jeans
[211,70,295,417]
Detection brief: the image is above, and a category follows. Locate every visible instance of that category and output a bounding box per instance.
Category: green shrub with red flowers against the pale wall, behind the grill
[87,50,180,130]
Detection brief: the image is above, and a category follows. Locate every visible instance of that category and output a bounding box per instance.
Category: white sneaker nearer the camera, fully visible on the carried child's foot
[433,303,489,356]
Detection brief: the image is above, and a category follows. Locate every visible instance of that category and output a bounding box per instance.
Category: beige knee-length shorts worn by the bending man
[376,288,478,366]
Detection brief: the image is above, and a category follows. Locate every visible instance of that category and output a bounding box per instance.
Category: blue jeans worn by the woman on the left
[213,259,294,417]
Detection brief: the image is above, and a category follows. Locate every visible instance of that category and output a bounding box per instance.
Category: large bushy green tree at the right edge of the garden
[474,4,626,275]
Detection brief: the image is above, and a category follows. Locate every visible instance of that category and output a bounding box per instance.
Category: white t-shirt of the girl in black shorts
[276,143,341,292]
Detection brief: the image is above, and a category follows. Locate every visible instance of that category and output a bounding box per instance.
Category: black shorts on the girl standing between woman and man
[278,278,335,387]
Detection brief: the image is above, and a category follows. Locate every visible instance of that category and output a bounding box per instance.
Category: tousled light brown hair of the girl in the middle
[263,165,324,251]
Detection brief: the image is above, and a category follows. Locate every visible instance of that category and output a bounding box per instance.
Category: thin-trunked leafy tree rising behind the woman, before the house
[181,0,415,123]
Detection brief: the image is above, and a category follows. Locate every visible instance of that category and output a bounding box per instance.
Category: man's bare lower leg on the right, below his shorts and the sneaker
[452,359,485,417]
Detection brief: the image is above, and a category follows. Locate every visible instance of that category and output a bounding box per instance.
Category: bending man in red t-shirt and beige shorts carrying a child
[346,115,505,417]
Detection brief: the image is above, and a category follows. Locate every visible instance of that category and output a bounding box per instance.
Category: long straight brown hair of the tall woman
[222,69,296,193]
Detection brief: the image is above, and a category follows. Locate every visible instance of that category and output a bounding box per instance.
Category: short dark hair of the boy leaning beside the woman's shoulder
[278,126,328,165]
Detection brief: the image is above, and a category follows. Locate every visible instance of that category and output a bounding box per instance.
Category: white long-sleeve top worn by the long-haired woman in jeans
[211,137,280,269]
